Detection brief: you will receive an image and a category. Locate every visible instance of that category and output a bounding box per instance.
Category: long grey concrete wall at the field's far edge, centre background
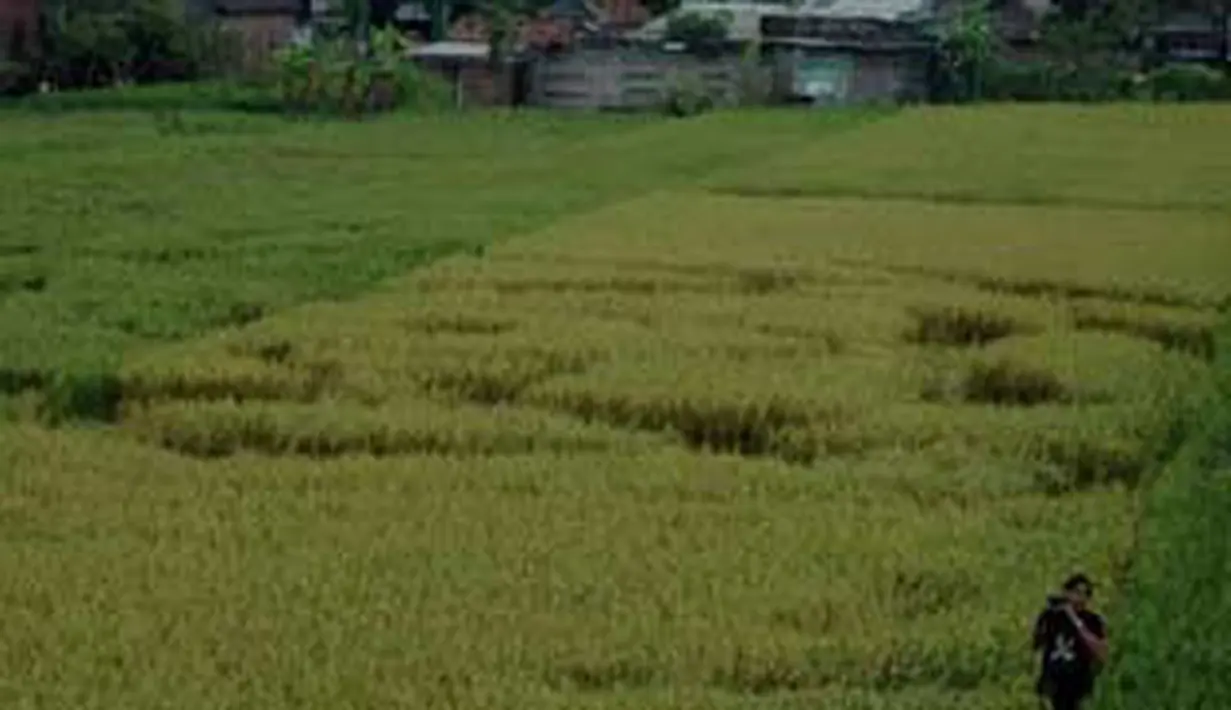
[529,49,742,108]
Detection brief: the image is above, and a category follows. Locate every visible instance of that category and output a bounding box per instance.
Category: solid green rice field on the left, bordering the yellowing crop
[0,112,874,393]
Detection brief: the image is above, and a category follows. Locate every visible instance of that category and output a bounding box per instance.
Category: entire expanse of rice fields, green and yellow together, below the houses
[0,105,1231,710]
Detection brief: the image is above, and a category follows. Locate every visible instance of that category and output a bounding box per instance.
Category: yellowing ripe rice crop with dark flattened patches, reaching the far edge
[0,102,1231,710]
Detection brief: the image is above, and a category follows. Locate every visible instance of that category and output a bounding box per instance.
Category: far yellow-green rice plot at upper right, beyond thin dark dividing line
[707,103,1231,213]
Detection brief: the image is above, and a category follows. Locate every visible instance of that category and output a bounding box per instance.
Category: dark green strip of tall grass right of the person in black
[1097,329,1231,710]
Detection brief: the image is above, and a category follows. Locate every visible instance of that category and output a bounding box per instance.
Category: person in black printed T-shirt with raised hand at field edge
[1034,575,1108,710]
